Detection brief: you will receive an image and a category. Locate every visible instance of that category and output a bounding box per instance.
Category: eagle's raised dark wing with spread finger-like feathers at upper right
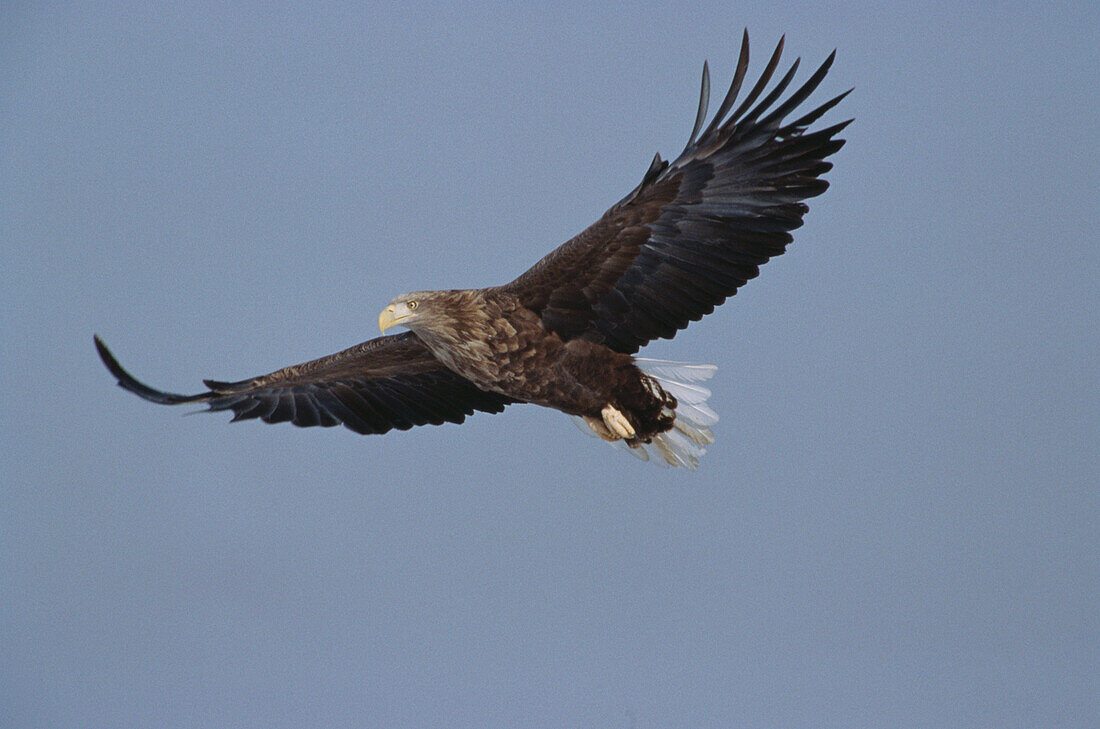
[502,32,850,354]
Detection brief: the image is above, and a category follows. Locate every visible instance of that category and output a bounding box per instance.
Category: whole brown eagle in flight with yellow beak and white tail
[95,31,851,468]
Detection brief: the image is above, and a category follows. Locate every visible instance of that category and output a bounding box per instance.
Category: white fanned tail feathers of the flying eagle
[572,357,718,468]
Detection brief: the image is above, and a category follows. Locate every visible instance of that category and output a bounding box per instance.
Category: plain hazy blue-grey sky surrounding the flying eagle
[0,2,1100,729]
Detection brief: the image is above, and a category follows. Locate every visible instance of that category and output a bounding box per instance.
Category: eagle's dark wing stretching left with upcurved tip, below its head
[95,332,515,433]
